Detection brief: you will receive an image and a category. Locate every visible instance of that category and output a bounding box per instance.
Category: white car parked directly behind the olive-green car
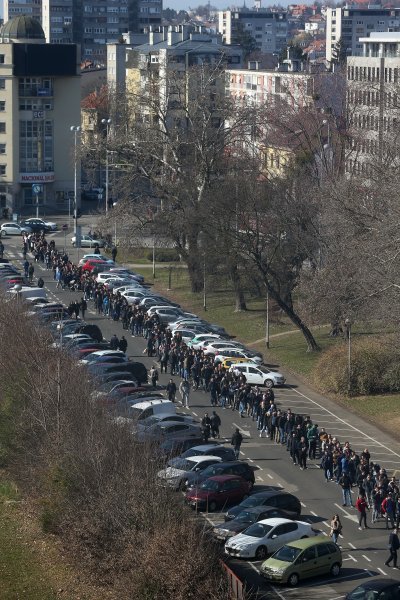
[225,518,320,560]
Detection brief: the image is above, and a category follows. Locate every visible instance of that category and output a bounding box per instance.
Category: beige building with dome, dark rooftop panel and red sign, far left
[0,16,81,213]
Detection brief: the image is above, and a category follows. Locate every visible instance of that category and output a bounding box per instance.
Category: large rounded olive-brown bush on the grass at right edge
[312,337,400,396]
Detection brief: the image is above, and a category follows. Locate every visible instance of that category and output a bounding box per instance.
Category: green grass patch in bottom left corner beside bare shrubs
[0,481,57,600]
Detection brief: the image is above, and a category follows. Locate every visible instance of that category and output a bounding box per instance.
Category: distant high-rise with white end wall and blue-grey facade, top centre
[218,9,288,54]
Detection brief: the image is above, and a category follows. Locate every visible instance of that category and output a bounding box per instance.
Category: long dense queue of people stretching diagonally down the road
[23,229,400,552]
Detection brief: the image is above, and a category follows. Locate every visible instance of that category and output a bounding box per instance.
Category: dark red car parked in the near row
[185,475,251,511]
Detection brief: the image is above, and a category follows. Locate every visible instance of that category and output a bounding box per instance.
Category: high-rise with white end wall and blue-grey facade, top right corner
[326,5,400,62]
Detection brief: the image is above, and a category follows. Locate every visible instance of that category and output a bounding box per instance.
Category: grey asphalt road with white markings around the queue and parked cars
[3,225,400,600]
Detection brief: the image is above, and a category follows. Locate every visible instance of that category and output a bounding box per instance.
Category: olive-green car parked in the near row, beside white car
[260,535,342,587]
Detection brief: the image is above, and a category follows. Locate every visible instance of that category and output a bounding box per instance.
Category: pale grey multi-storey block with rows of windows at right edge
[346,32,400,177]
